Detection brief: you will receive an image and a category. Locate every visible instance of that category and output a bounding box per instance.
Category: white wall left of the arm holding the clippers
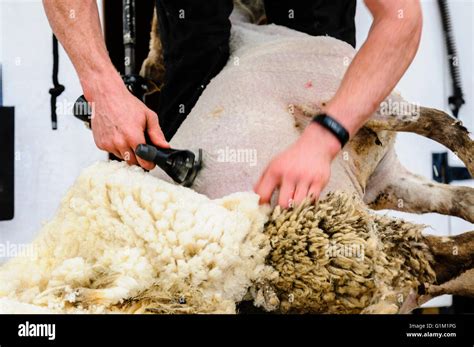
[0,0,106,251]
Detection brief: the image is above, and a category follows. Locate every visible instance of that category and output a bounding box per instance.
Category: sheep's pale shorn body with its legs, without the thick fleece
[121,0,474,309]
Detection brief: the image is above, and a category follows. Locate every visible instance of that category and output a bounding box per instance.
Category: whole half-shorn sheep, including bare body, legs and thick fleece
[0,0,474,313]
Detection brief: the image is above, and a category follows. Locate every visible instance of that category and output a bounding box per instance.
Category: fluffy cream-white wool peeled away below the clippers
[0,162,269,312]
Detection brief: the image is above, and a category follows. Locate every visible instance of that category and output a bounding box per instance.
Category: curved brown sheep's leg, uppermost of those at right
[366,106,474,176]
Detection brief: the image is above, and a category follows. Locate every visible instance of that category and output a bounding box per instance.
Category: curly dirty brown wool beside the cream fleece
[264,193,435,313]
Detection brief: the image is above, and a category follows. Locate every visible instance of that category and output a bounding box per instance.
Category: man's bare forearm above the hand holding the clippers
[43,0,121,97]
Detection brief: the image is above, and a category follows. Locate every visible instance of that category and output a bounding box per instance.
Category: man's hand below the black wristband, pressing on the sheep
[254,123,341,208]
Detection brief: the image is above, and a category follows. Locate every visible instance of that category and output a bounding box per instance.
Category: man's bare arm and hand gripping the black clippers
[43,0,169,169]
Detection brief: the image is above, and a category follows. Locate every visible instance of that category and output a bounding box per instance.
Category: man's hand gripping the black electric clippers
[84,82,169,170]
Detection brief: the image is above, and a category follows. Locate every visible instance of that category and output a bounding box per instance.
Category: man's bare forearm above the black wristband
[325,0,422,136]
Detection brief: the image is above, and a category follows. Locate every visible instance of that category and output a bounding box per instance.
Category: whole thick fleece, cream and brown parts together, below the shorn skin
[0,162,474,313]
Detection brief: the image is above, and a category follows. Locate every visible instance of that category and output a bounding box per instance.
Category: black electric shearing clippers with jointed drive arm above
[74,0,202,187]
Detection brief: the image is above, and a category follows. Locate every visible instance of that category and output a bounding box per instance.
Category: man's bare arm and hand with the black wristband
[255,0,422,207]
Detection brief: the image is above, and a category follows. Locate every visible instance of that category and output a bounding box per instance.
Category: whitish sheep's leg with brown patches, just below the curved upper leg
[364,149,474,223]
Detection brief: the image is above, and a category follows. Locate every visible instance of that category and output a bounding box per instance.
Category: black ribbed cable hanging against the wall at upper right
[438,0,465,118]
